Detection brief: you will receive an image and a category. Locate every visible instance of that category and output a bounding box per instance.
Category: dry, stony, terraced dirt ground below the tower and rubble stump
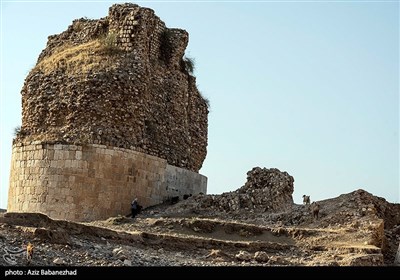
[0,190,400,266]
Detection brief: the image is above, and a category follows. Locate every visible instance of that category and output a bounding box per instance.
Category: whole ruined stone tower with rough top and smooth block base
[7,4,208,221]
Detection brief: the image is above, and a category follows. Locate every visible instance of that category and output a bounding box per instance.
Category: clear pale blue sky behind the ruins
[0,1,400,208]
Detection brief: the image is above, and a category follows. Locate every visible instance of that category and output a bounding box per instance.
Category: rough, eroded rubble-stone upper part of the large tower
[15,3,208,172]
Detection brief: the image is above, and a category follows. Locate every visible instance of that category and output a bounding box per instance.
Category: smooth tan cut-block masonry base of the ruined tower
[7,142,207,221]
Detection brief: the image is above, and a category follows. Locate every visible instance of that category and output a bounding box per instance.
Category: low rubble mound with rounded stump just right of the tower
[161,167,294,217]
